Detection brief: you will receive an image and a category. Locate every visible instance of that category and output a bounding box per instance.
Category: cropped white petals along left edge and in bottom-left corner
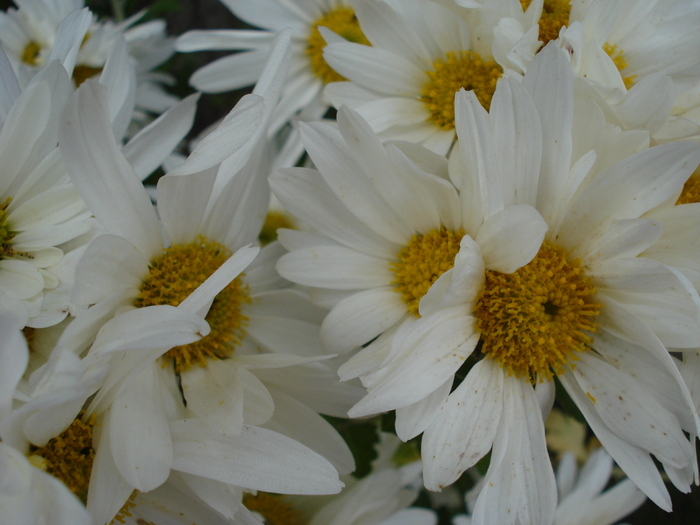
[0,313,91,525]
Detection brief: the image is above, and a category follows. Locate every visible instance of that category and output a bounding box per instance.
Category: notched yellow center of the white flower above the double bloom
[421,51,503,130]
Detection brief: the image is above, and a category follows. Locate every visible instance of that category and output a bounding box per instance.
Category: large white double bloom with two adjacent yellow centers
[273,46,700,523]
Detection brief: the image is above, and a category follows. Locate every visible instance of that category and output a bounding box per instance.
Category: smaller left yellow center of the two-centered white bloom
[389,228,464,315]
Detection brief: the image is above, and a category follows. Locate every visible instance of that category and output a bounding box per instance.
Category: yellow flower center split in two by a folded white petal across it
[134,236,250,373]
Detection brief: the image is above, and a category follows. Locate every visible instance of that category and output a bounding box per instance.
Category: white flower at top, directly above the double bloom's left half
[322,0,507,154]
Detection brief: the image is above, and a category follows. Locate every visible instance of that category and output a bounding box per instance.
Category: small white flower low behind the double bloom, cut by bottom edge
[452,449,646,525]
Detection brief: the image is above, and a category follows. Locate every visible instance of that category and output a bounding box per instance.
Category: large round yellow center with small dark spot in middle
[474,241,601,383]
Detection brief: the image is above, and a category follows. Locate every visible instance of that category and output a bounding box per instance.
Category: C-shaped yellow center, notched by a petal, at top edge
[306,6,370,84]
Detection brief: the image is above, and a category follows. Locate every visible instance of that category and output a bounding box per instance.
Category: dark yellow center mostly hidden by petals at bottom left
[29,418,95,503]
